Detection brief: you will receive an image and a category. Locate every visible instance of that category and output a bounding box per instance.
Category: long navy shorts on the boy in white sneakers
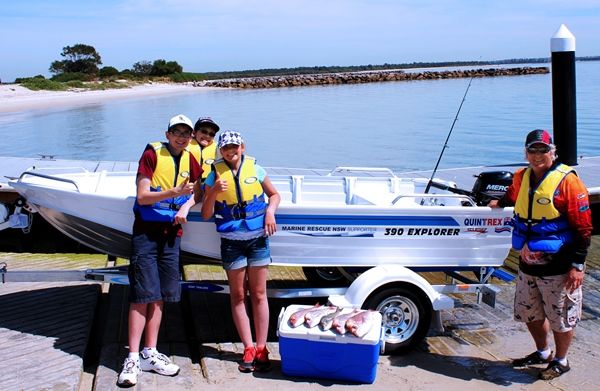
[129,233,181,304]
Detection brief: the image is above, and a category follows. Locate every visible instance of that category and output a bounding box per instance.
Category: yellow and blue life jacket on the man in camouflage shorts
[512,164,573,253]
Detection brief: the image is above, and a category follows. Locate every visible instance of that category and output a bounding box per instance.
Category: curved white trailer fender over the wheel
[329,265,454,311]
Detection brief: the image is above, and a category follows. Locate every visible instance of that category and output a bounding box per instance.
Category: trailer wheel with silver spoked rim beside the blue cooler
[363,287,432,354]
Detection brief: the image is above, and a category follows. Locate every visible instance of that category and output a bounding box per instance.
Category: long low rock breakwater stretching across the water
[202,67,550,88]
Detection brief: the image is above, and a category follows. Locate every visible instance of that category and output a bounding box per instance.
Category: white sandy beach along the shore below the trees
[0,83,211,113]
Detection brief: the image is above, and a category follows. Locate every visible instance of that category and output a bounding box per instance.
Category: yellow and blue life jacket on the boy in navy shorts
[133,142,190,222]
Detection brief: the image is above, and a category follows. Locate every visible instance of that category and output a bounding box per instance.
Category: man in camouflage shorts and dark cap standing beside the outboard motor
[490,129,592,380]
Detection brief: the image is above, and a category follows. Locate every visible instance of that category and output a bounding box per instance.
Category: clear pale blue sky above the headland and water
[0,0,600,81]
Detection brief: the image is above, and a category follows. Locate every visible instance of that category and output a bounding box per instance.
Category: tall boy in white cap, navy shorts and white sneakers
[117,114,202,386]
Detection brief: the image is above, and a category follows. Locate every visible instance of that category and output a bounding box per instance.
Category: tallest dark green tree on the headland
[50,43,102,75]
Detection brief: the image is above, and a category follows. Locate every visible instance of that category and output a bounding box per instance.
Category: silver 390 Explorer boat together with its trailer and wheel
[7,167,512,353]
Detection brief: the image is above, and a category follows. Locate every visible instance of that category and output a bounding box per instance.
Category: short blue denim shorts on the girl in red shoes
[221,236,271,270]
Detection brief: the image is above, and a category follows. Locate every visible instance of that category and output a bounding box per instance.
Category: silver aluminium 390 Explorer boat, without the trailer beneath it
[10,168,512,270]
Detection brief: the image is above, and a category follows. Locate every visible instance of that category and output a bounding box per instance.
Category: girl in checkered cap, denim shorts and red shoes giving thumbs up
[202,131,281,372]
